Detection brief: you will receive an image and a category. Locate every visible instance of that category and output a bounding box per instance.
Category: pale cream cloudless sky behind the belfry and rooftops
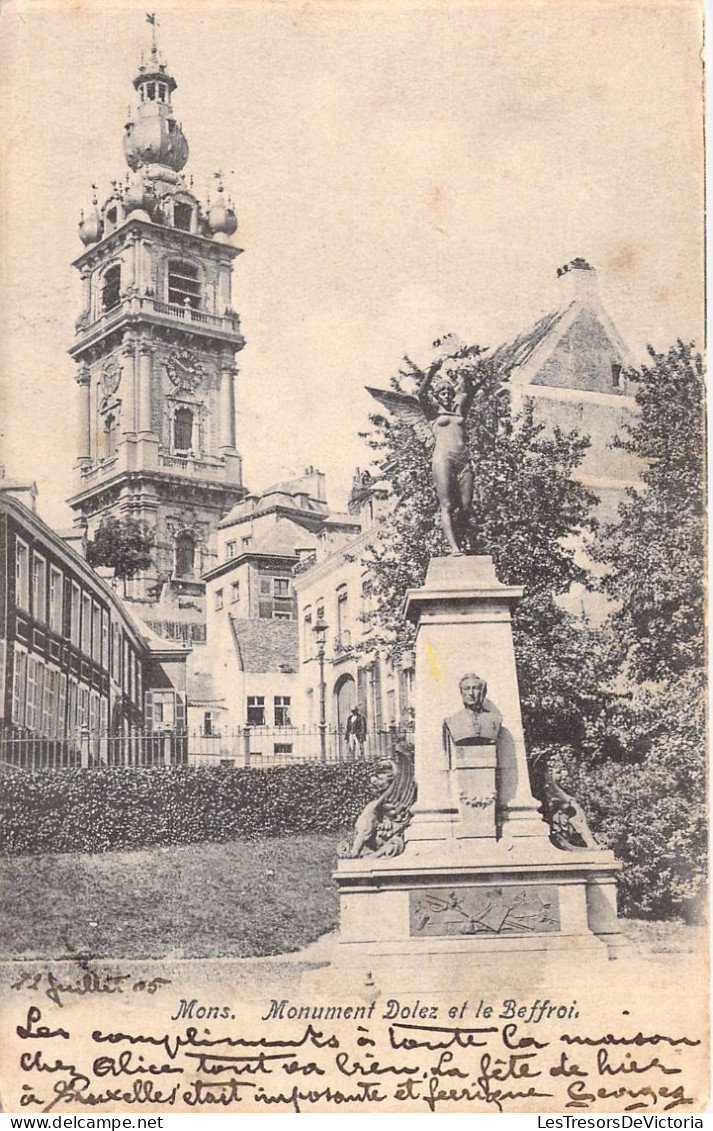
[0,0,703,528]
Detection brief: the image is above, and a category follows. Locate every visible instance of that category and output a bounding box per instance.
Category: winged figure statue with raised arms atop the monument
[367,357,484,555]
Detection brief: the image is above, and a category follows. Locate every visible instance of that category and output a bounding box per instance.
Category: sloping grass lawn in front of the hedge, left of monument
[0,835,340,958]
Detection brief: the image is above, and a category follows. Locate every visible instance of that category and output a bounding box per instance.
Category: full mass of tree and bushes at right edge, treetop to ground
[556,342,707,916]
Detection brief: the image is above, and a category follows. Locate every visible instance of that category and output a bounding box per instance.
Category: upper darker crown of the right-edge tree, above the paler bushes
[593,342,705,683]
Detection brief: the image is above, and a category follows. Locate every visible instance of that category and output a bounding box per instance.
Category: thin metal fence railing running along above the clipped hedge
[0,725,410,770]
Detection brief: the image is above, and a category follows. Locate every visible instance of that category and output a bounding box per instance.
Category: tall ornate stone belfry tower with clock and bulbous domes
[69,18,246,601]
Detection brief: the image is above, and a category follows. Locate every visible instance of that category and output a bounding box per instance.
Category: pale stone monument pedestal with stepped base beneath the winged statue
[325,558,626,990]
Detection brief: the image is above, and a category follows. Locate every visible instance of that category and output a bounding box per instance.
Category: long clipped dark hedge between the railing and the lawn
[0,761,383,855]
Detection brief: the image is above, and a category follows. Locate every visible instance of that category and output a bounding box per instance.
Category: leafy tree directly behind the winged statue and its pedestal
[367,346,602,751]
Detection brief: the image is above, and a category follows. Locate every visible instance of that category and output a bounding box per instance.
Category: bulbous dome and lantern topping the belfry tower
[123,35,188,173]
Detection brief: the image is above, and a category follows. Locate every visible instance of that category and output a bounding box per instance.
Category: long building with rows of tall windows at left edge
[0,482,188,753]
